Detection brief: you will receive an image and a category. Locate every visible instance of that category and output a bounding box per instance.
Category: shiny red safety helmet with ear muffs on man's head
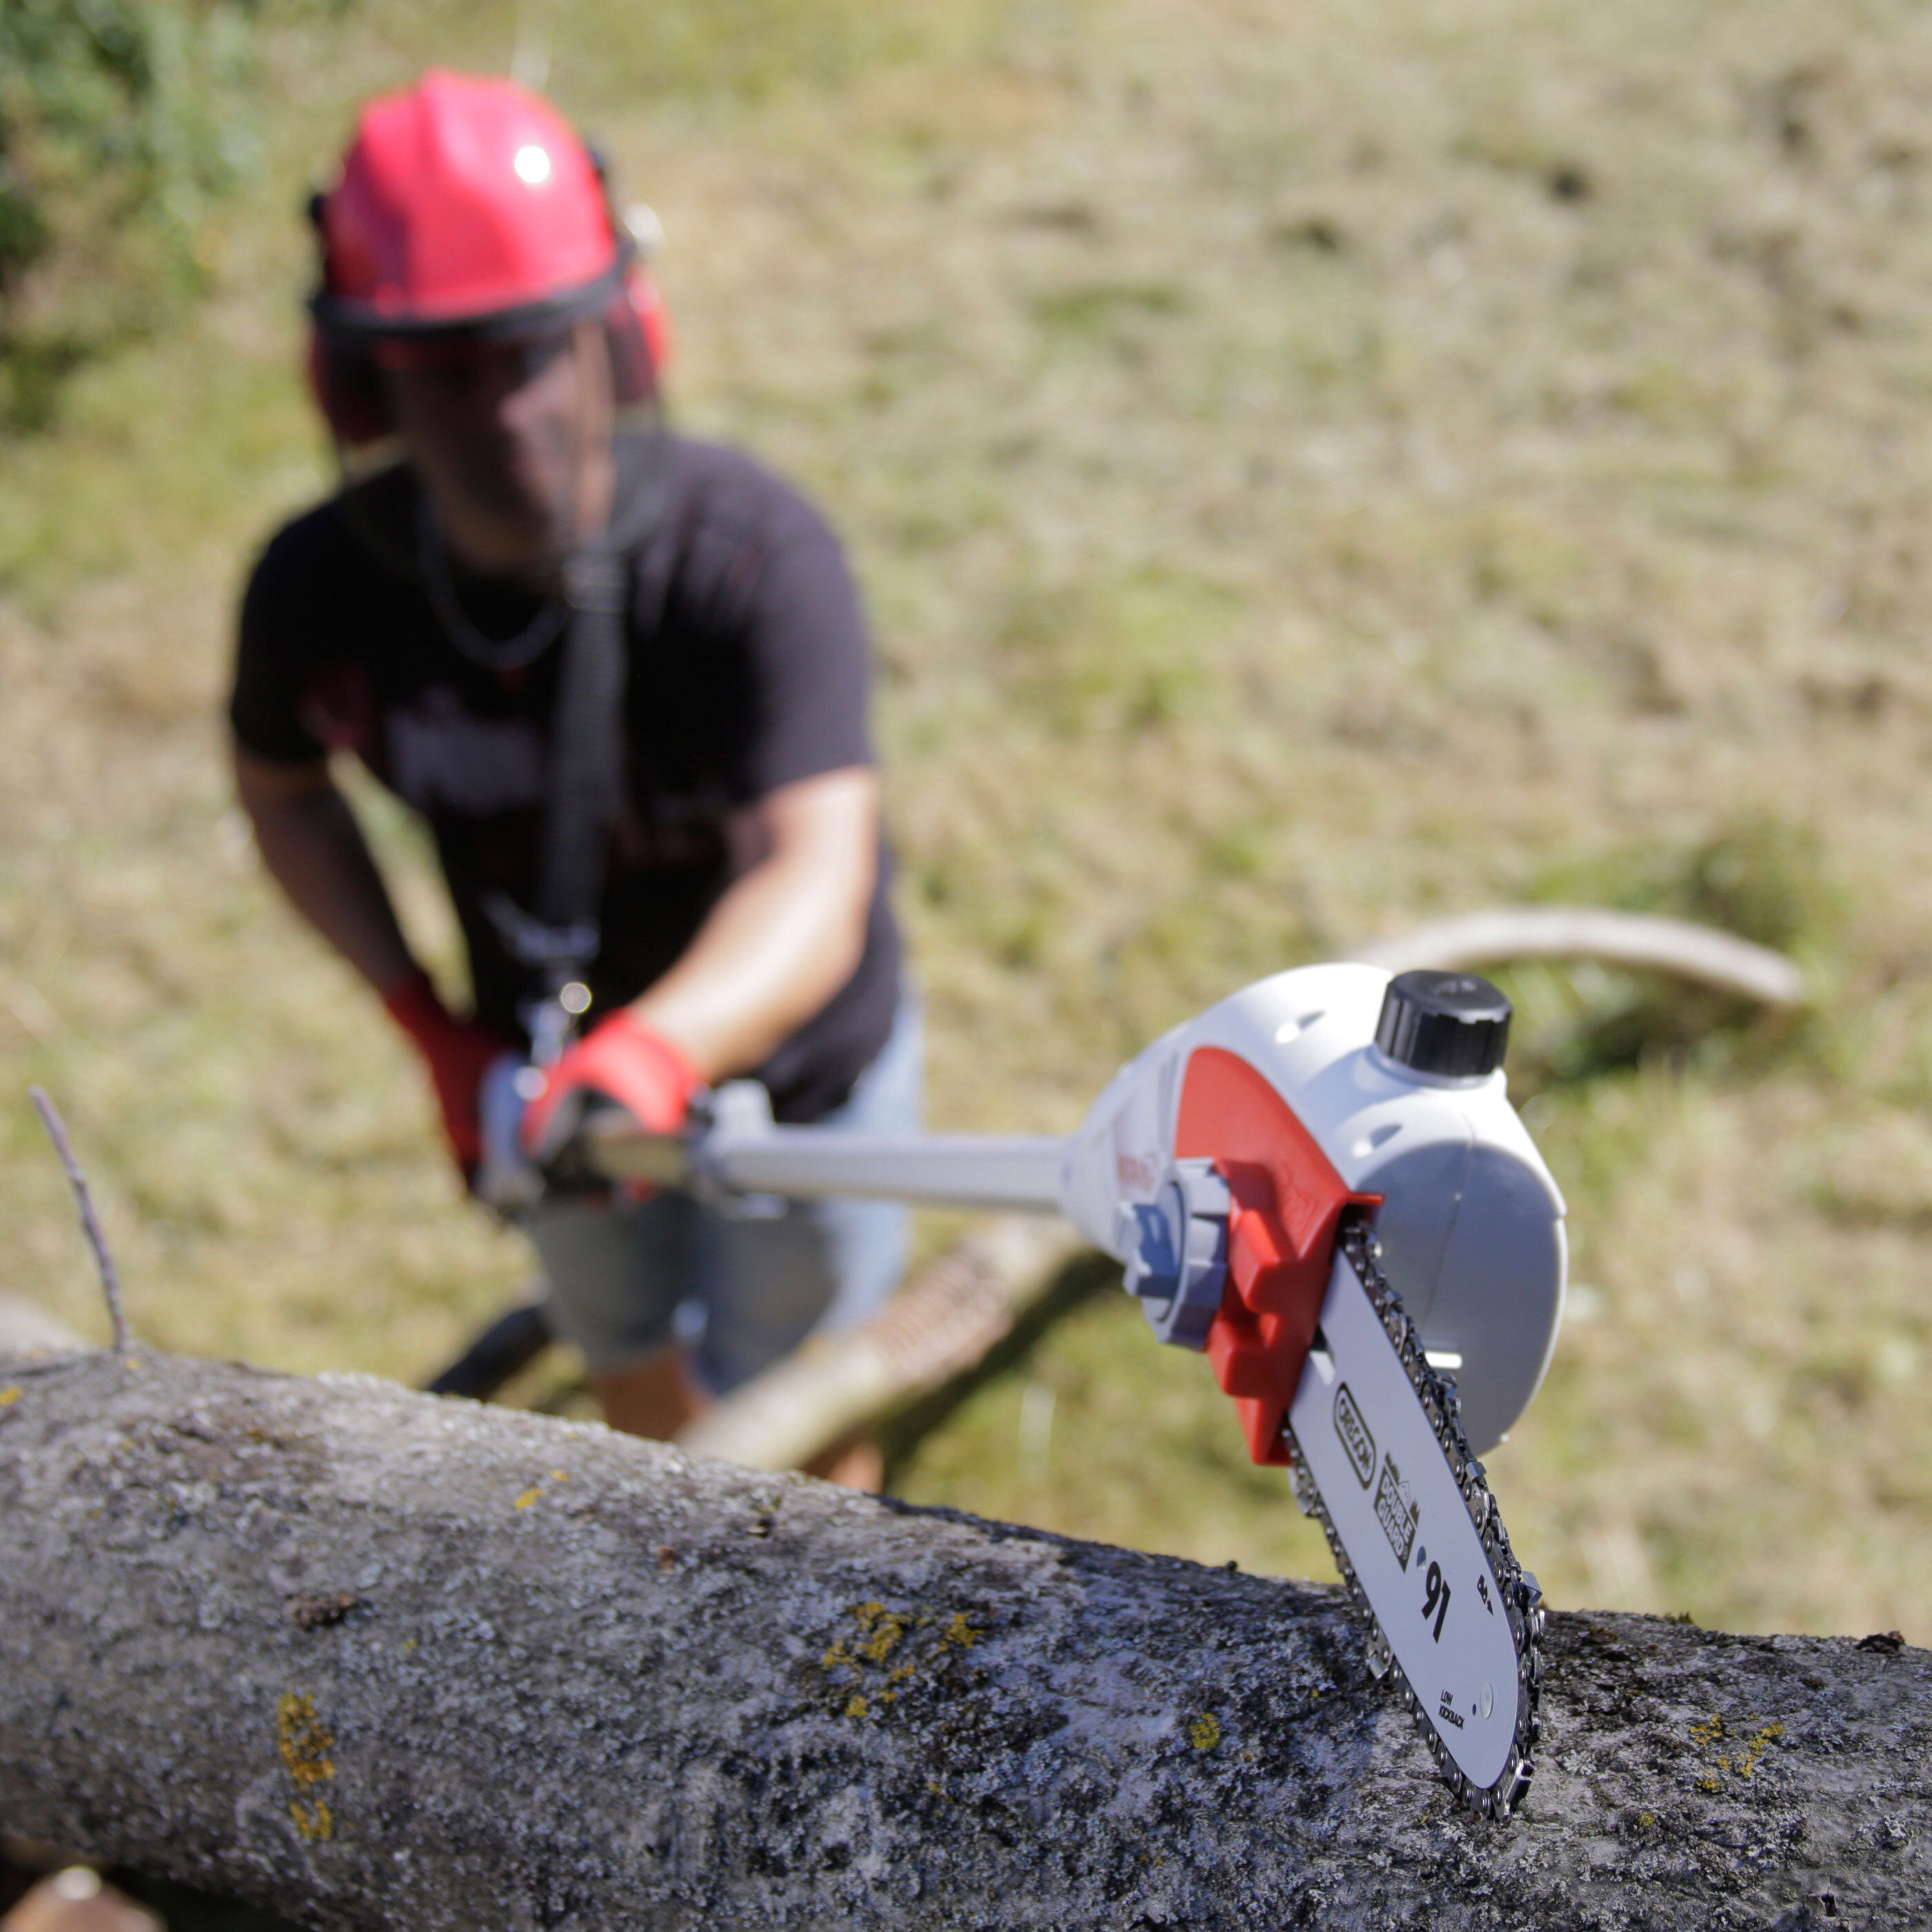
[309,70,671,446]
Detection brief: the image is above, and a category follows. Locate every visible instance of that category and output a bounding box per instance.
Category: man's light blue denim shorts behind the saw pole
[526,991,925,1395]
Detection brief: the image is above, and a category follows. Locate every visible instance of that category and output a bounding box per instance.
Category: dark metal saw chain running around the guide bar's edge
[1281,1221,1544,1822]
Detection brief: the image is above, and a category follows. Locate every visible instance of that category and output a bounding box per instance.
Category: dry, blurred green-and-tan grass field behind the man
[0,0,1932,1644]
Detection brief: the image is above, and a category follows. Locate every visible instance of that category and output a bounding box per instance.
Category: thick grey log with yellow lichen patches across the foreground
[0,1354,1932,1932]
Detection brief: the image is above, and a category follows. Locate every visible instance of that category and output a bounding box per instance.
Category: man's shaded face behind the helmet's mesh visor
[377,321,613,584]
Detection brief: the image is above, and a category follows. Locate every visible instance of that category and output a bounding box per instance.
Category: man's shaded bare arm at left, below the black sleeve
[234,746,415,999]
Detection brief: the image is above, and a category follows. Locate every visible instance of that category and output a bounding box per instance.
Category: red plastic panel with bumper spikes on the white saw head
[1174,1047,1381,1464]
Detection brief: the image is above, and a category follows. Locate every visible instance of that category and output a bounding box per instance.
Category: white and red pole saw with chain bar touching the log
[512,964,1565,1818]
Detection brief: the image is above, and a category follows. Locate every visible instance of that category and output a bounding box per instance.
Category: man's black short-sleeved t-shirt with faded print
[230,437,900,1121]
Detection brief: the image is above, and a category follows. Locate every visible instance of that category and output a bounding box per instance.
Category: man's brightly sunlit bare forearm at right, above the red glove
[630,765,879,1082]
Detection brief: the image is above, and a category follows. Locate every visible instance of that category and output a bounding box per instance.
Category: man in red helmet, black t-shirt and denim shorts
[230,73,920,1474]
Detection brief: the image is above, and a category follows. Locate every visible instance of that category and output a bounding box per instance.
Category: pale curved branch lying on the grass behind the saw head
[1350,906,1804,1010]
